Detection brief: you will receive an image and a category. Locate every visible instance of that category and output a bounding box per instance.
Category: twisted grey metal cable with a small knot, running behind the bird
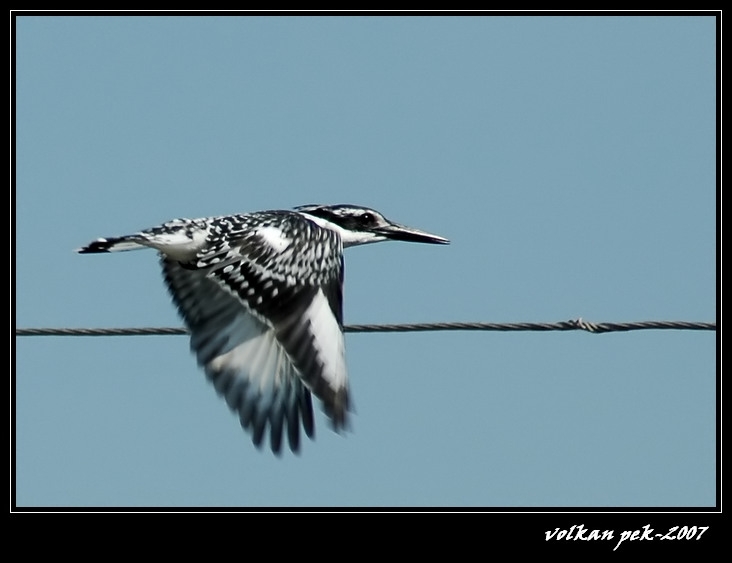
[15,318,717,336]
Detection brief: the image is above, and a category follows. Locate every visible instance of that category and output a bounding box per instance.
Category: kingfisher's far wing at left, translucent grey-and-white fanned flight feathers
[162,258,320,453]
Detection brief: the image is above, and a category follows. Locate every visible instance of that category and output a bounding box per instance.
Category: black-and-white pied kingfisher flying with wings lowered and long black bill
[77,205,449,455]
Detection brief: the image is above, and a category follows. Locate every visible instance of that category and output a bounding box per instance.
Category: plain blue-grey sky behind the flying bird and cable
[14,15,717,507]
